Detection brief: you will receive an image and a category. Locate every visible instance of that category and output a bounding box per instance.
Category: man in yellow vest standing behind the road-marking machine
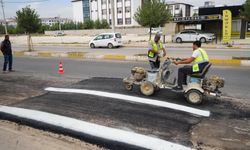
[148,33,166,69]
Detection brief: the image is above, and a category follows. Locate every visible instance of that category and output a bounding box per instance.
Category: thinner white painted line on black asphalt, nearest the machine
[45,87,210,117]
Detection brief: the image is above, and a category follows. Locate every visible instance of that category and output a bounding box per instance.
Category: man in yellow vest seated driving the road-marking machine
[173,41,209,91]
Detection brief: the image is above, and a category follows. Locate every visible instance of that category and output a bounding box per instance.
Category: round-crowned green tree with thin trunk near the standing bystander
[16,6,42,51]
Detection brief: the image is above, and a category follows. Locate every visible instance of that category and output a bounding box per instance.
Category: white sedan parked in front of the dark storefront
[173,30,215,43]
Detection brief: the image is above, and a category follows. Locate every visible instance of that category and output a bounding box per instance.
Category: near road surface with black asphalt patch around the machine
[0,57,250,149]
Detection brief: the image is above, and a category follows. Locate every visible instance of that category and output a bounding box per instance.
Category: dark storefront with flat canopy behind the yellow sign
[174,5,250,40]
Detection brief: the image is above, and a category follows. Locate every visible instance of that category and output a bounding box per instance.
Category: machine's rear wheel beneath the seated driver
[185,89,203,105]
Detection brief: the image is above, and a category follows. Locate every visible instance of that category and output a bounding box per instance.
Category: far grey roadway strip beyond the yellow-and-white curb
[13,45,250,59]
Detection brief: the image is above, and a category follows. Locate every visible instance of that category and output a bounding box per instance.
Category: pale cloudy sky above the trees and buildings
[0,0,245,18]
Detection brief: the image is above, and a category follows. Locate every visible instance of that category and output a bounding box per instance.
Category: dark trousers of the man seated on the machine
[178,66,193,87]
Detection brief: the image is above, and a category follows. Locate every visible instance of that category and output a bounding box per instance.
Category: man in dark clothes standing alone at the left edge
[1,35,13,73]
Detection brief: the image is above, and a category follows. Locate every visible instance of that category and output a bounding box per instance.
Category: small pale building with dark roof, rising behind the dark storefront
[166,1,194,17]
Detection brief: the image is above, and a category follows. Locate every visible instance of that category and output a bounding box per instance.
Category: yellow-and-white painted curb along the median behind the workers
[1,51,250,66]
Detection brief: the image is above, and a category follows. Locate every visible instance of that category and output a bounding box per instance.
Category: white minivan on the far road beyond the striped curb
[89,33,122,48]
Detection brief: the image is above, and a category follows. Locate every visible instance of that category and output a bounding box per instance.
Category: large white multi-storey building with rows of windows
[72,0,143,27]
